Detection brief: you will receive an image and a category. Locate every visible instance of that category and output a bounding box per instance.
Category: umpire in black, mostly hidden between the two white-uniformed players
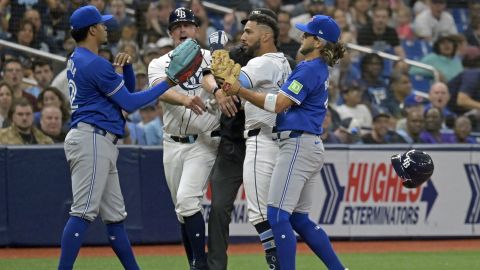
[204,47,251,270]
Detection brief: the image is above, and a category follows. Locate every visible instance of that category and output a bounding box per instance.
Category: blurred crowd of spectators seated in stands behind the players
[0,0,480,145]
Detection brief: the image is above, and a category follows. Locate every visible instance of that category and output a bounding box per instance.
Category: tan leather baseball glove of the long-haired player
[211,50,241,96]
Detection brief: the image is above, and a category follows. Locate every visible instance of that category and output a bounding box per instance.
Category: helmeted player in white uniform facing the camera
[148,8,220,269]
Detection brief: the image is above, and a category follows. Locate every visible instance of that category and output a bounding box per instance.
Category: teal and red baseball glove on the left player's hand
[166,39,203,84]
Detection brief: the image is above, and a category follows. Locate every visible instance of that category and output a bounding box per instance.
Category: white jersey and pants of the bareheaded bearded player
[241,53,291,225]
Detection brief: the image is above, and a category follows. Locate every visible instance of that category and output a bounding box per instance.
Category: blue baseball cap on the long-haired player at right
[295,15,340,43]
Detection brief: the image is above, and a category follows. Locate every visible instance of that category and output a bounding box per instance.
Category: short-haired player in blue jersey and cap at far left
[58,6,200,269]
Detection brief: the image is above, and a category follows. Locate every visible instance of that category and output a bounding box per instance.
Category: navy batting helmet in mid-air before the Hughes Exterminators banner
[391,149,433,188]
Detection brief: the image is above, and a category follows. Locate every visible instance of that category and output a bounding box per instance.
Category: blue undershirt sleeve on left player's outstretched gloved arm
[110,81,170,113]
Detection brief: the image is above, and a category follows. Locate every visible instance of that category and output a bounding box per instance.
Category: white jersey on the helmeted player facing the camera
[148,49,220,135]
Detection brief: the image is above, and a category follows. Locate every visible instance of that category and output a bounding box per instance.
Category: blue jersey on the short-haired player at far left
[67,47,125,137]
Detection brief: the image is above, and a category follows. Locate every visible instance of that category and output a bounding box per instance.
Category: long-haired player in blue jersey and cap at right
[223,15,345,270]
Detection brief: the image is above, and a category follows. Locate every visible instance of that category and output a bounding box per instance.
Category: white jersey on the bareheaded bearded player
[241,52,292,129]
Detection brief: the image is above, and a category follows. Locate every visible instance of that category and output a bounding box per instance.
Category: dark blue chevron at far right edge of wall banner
[464,164,480,224]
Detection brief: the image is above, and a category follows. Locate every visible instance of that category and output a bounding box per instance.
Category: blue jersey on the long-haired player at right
[277,58,328,135]
